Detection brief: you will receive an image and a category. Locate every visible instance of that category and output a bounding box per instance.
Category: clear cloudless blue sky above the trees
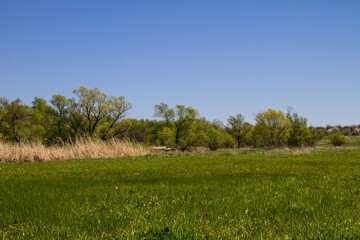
[0,0,360,126]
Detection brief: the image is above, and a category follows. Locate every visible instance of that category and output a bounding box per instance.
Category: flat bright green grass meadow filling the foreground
[0,148,360,239]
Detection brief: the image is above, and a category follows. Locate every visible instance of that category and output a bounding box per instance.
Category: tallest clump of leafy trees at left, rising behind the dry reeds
[0,87,131,144]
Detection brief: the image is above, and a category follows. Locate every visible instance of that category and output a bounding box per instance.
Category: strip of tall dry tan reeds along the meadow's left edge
[0,139,149,162]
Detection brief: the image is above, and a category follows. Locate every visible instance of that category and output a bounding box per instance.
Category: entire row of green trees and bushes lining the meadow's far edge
[0,87,332,150]
